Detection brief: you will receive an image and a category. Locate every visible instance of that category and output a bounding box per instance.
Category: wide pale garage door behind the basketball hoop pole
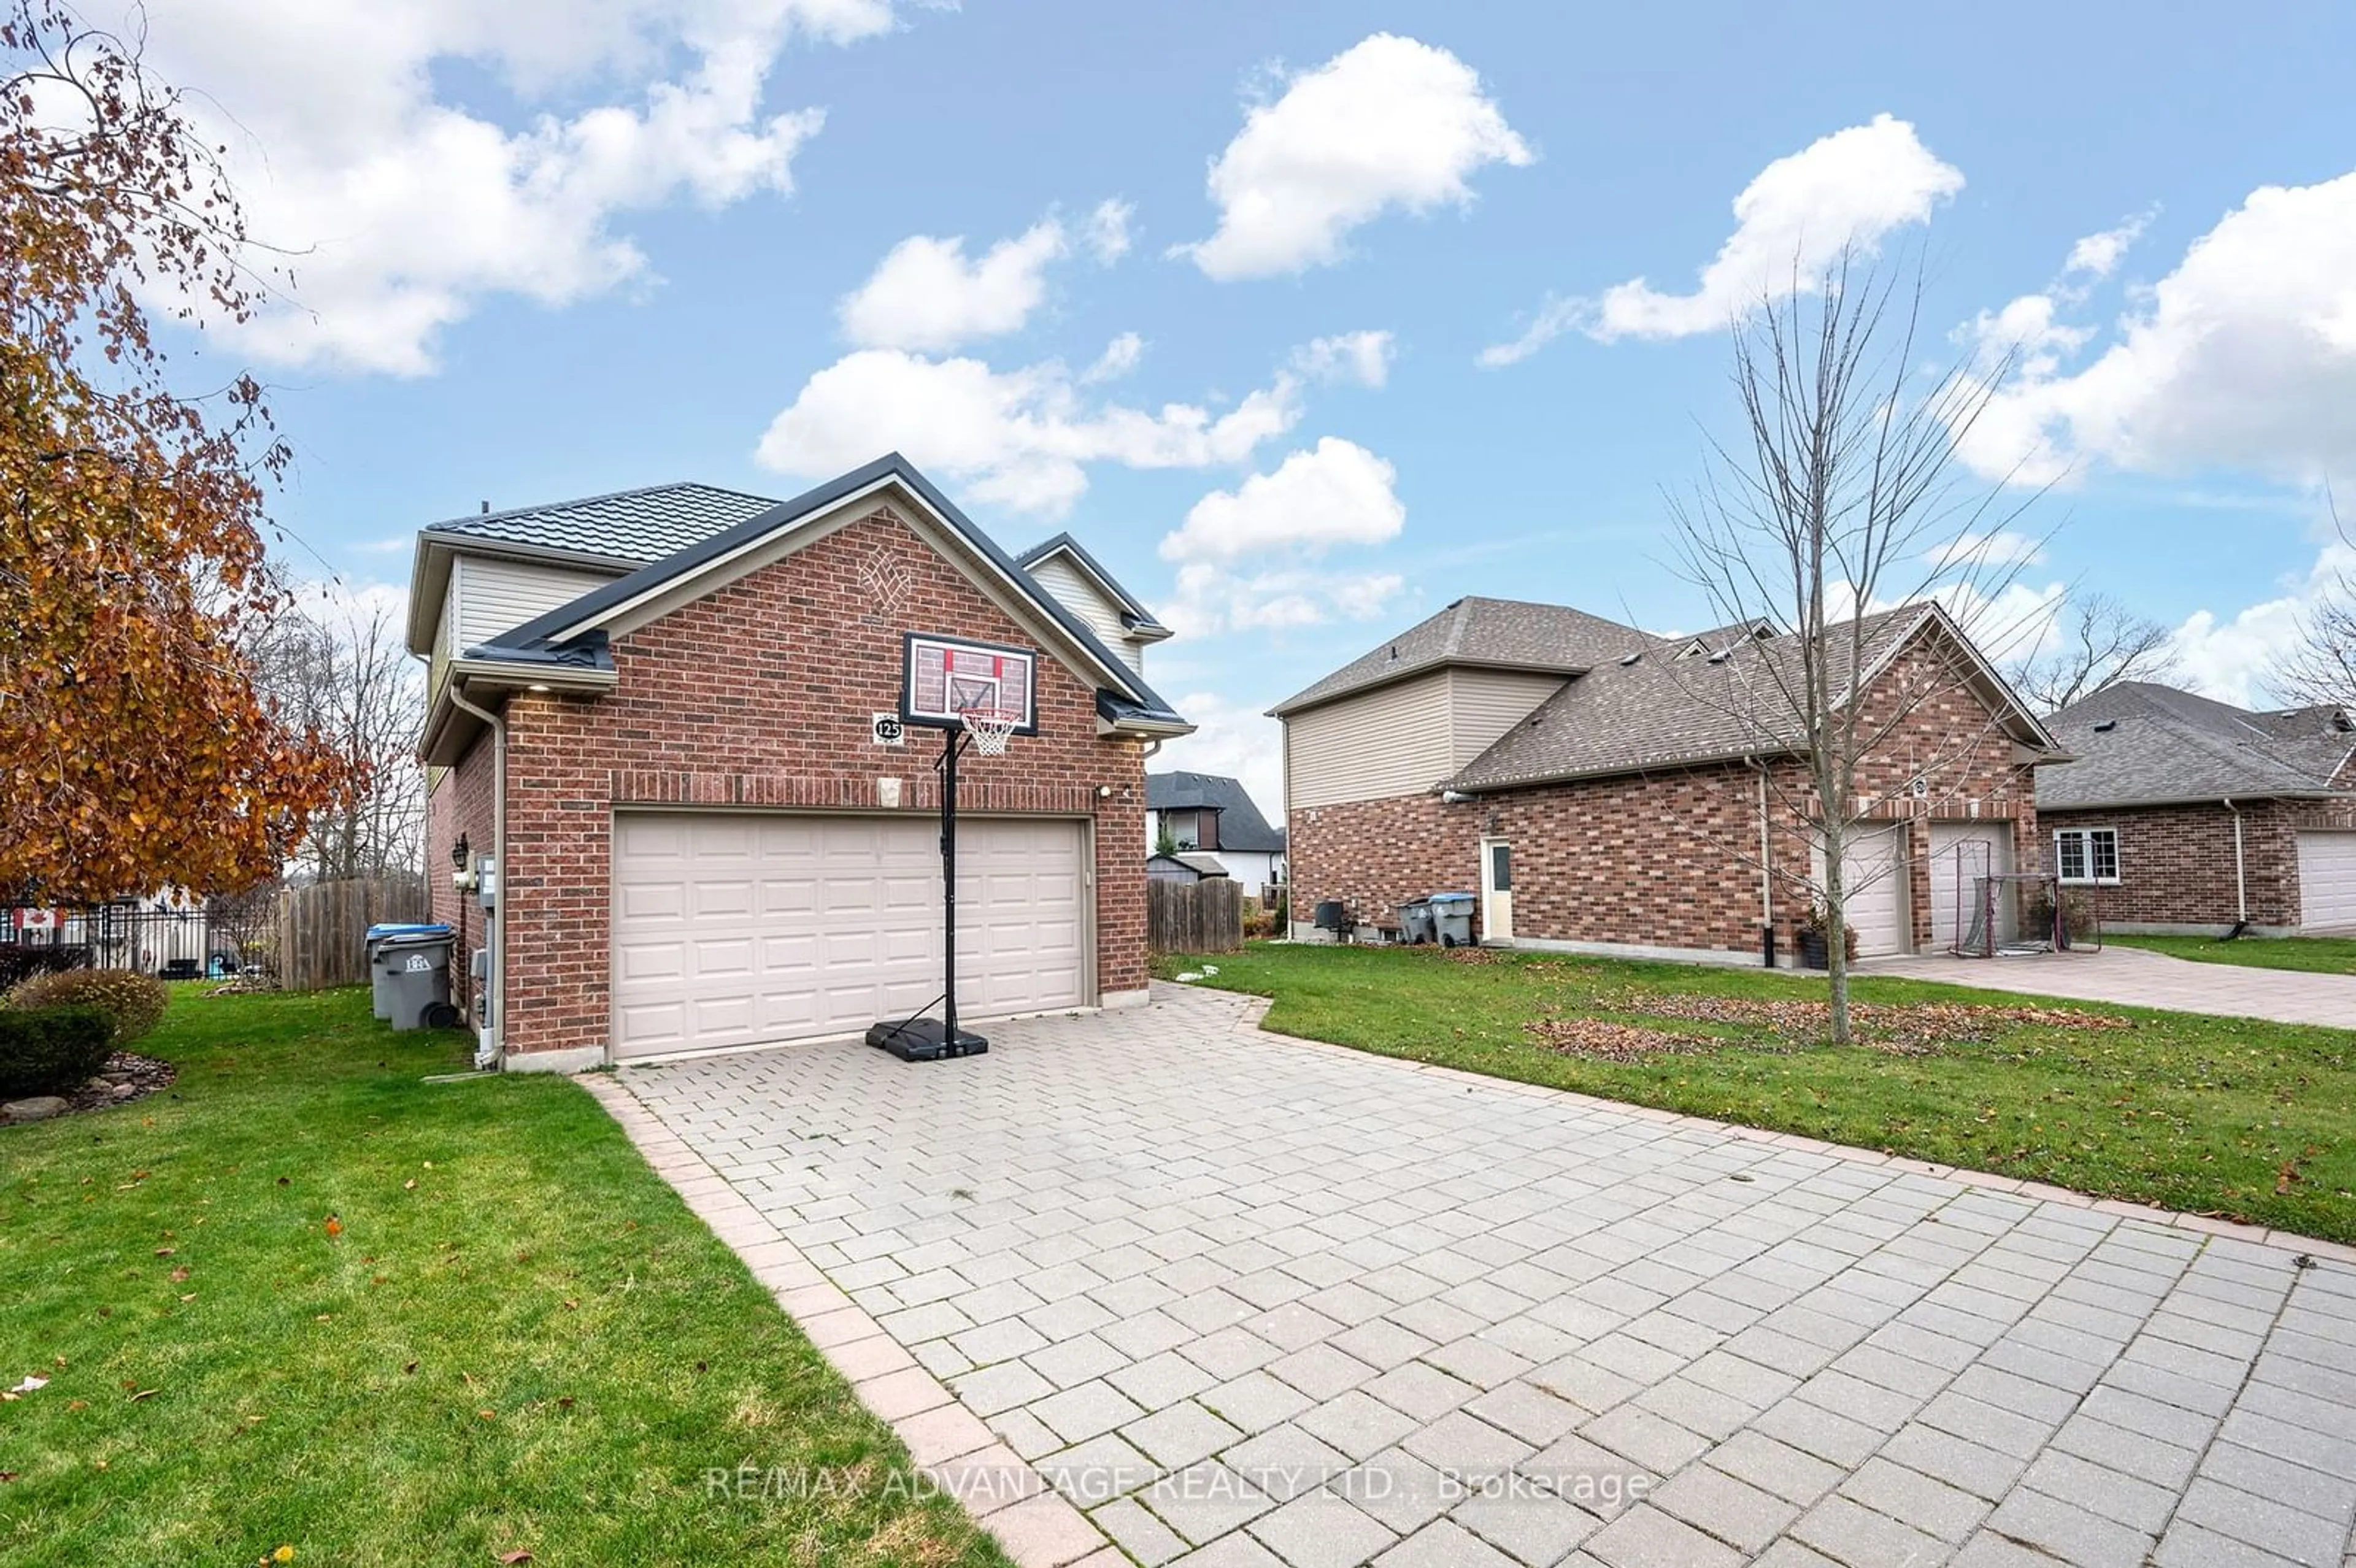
[612,812,1086,1057]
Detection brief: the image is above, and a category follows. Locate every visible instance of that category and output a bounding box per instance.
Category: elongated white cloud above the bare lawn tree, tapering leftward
[1480,115,1963,367]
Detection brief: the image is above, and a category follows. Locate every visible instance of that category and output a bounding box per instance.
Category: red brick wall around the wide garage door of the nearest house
[483,513,1147,1053]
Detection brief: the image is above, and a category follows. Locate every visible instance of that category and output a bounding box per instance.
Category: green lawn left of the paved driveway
[0,986,1006,1568]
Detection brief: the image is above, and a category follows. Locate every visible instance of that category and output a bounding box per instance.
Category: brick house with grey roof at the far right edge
[2038,680,2356,935]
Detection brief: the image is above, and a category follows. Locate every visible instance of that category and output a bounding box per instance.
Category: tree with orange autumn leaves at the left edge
[0,0,346,904]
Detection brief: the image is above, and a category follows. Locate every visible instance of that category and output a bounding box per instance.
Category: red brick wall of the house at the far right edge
[2042,801,2356,928]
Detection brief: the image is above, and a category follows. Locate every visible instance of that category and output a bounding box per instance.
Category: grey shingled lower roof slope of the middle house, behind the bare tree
[1447,605,1944,791]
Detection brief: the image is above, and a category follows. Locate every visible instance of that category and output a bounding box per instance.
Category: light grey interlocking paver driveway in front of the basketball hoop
[598,986,2356,1568]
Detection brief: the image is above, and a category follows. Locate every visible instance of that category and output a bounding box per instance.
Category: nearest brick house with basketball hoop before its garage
[407,455,1190,1071]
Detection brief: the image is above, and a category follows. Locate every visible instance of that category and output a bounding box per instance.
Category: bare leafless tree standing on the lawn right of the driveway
[1671,252,2033,1045]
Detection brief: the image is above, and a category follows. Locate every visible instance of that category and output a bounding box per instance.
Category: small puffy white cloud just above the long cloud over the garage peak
[836,219,1072,348]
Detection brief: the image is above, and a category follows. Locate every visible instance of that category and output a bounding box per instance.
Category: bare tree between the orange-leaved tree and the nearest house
[257,605,426,880]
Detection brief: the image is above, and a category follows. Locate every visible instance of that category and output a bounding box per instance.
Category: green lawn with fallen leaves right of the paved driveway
[1164,944,2356,1241]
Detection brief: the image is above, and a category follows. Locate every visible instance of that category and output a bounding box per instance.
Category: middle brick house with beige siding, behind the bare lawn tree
[1272,598,2054,963]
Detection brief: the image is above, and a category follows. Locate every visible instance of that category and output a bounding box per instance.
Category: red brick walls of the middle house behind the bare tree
[1288,631,2038,953]
